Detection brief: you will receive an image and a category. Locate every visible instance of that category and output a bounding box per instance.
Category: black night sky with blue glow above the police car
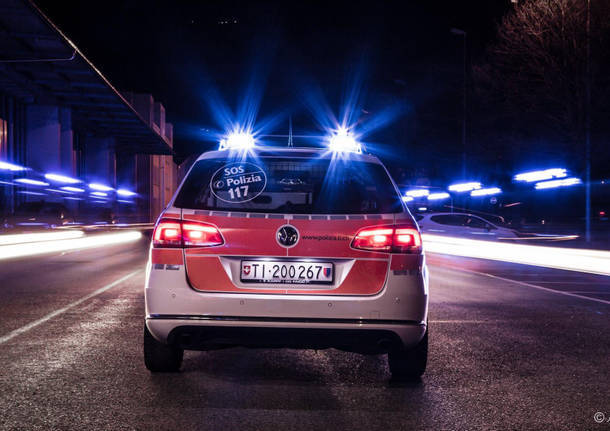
[36,0,509,179]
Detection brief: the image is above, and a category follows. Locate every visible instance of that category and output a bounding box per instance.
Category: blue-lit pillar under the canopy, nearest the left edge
[25,105,61,172]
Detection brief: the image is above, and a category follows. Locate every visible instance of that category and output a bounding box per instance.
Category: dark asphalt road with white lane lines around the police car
[0,242,610,431]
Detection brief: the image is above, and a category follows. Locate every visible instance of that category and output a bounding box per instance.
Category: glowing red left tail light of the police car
[153,219,224,248]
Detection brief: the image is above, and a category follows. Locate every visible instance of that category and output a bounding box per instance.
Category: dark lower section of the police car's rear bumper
[146,315,426,354]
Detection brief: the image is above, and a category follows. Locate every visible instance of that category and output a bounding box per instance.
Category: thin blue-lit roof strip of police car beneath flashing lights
[197,146,381,164]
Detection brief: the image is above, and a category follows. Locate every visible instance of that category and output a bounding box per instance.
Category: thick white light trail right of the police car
[422,234,610,275]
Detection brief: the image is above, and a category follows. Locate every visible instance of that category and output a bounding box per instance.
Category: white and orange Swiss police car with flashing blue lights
[144,133,428,380]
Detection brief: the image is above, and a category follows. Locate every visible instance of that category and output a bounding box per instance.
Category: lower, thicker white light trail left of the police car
[0,231,142,260]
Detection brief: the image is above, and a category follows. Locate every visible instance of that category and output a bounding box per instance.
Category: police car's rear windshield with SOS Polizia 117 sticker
[174,157,403,214]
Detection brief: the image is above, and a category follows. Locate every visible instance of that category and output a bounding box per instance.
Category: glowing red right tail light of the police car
[352,225,422,253]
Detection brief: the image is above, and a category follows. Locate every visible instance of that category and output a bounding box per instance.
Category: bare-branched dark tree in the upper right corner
[473,0,610,172]
